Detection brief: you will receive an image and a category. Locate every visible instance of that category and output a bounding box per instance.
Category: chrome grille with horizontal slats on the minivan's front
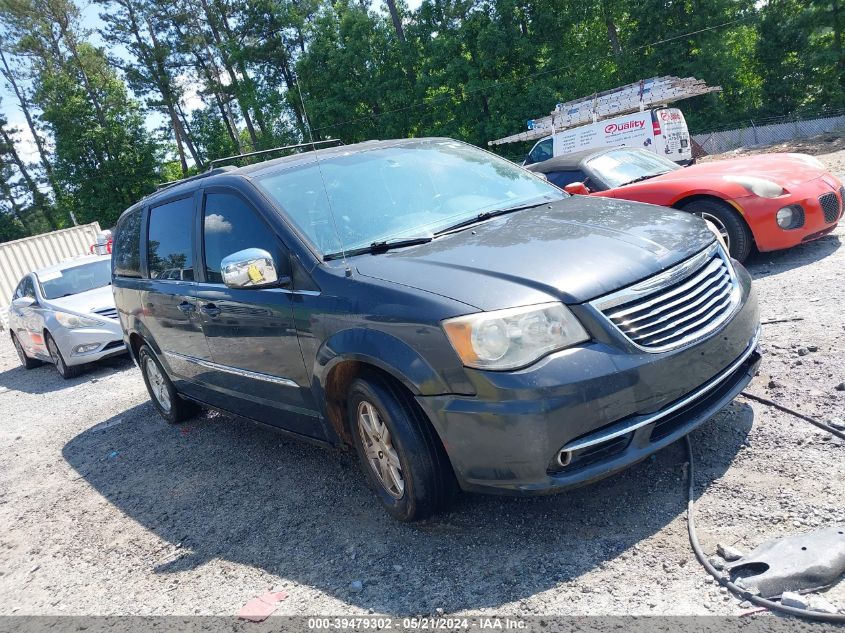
[593,244,740,352]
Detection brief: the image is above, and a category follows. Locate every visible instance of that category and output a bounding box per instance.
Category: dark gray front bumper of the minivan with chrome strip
[417,266,760,495]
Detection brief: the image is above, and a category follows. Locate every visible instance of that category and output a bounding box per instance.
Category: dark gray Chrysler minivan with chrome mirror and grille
[113,138,760,520]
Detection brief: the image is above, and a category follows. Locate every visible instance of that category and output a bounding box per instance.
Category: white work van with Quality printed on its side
[523,108,692,165]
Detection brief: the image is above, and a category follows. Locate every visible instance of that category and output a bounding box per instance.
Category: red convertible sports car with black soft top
[526,147,845,261]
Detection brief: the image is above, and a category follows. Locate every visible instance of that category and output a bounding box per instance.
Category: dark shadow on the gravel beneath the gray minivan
[63,403,753,615]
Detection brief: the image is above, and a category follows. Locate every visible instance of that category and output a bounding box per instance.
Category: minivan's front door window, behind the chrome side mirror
[203,193,281,284]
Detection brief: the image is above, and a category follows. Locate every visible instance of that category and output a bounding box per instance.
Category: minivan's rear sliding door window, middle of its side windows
[147,197,194,281]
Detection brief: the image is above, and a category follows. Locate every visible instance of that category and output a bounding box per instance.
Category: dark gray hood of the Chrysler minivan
[353,196,713,310]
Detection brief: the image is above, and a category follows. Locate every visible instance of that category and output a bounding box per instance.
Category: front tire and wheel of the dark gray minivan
[347,375,455,521]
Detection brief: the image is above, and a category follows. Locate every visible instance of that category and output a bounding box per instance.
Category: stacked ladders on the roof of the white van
[487,75,722,146]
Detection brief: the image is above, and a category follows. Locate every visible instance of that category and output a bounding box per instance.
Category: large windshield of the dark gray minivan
[256,139,567,257]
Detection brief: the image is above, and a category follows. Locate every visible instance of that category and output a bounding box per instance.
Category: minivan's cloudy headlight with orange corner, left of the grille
[443,303,590,369]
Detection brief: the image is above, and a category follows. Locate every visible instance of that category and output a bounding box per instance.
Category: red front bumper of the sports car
[731,175,845,251]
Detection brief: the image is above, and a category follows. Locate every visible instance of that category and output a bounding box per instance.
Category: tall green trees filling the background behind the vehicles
[0,0,845,239]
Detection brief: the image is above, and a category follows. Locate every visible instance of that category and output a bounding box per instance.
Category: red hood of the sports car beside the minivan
[645,154,827,189]
